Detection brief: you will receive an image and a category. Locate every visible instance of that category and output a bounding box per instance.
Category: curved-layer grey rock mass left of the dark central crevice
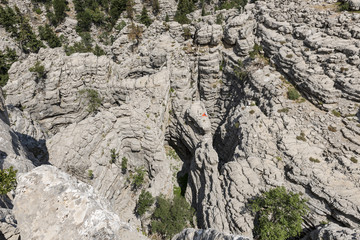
[6,37,173,224]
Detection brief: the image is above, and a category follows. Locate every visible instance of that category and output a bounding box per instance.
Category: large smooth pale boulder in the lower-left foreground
[14,165,145,240]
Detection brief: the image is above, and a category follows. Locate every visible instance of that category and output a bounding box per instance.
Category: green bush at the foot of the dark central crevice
[151,195,195,239]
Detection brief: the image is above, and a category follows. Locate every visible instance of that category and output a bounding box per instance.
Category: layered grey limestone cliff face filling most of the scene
[0,0,360,239]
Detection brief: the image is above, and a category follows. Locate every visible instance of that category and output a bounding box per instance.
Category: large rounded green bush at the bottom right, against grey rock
[250,187,308,240]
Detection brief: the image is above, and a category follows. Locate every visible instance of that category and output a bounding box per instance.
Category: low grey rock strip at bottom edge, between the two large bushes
[172,228,249,240]
